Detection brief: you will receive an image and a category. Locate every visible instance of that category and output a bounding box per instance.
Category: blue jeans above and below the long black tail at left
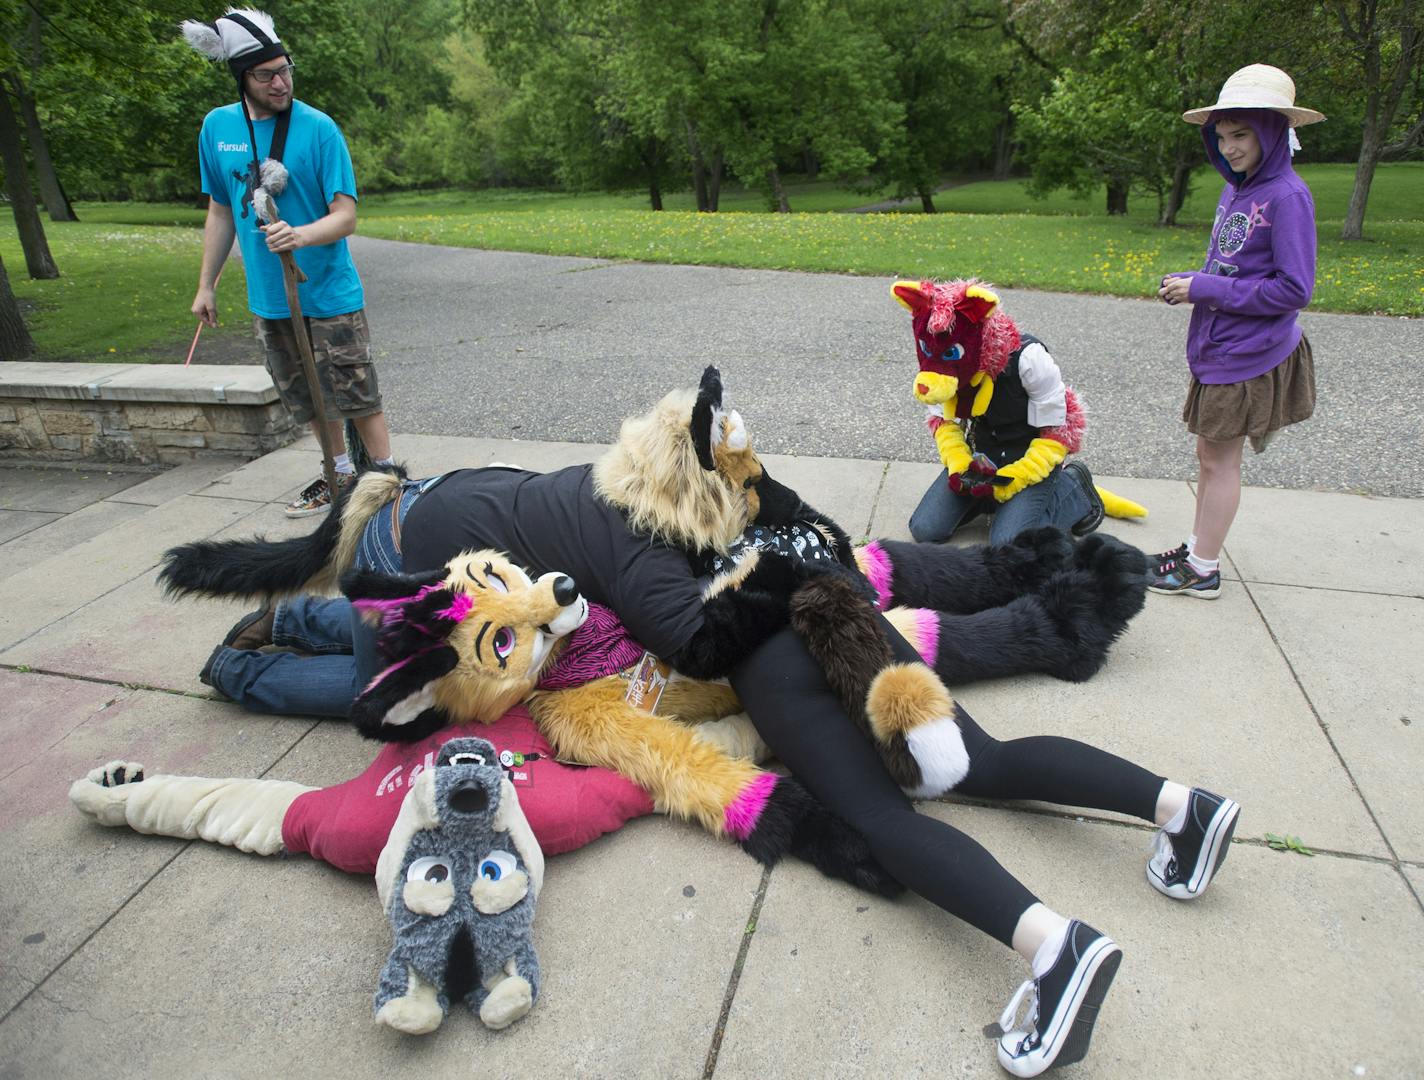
[208,477,439,720]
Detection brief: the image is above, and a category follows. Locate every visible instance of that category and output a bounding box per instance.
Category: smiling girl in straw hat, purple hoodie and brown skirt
[1151,64,1324,600]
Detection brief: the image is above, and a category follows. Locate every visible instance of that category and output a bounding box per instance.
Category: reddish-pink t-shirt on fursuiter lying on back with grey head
[282,705,652,873]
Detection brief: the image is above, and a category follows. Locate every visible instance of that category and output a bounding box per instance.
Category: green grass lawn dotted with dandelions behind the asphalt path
[8,162,1424,362]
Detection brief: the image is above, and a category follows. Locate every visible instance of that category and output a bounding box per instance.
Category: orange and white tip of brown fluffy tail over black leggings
[866,664,970,798]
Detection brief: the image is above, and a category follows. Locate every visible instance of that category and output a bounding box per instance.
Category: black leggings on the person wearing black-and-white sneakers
[732,620,1163,947]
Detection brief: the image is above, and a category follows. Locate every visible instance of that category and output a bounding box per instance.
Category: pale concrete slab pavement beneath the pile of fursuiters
[0,436,1424,1080]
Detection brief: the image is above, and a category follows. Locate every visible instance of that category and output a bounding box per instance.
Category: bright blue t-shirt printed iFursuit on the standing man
[198,101,366,319]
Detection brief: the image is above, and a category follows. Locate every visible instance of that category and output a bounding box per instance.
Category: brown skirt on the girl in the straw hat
[1182,335,1316,453]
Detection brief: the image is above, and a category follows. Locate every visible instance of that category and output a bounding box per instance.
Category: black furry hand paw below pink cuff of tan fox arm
[740,777,904,896]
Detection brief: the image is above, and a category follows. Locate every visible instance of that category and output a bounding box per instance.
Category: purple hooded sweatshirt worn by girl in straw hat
[1178,108,1316,383]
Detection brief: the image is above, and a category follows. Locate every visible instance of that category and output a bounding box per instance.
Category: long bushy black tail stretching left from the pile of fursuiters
[158,504,342,598]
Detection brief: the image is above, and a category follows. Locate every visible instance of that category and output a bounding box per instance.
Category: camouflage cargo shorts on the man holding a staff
[252,309,382,423]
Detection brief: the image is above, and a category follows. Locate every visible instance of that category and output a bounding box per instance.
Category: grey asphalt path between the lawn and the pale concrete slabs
[356,239,1424,496]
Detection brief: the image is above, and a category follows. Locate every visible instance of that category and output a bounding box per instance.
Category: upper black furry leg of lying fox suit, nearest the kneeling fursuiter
[864,526,1074,614]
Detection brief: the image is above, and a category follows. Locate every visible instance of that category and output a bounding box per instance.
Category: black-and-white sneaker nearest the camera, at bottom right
[998,919,1122,1076]
